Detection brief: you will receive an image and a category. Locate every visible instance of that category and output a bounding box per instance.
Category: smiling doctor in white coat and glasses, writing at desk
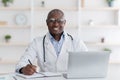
[16,9,87,75]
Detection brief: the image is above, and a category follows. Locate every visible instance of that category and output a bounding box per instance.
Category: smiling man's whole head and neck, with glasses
[46,9,66,41]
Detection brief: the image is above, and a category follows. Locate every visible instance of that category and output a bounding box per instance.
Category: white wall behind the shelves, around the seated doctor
[0,0,120,71]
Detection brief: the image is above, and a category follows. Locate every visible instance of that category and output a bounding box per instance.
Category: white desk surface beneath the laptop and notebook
[0,64,120,80]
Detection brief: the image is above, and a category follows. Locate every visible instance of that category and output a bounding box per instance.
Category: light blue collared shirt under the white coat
[50,33,64,56]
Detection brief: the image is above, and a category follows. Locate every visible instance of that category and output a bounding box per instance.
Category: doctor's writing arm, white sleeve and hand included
[16,40,37,75]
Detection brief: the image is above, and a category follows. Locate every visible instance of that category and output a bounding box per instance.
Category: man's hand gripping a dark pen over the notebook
[21,64,37,75]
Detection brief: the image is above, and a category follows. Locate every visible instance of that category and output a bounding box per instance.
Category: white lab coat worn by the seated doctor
[16,33,87,72]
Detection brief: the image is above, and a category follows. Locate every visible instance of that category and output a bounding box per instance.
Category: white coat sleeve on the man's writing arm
[16,40,37,73]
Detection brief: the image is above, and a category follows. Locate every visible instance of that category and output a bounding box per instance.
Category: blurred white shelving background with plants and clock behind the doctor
[0,0,120,73]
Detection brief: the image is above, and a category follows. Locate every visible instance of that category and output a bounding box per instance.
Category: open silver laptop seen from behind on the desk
[63,51,110,79]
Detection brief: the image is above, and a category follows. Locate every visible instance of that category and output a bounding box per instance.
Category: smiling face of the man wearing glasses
[46,13,66,35]
